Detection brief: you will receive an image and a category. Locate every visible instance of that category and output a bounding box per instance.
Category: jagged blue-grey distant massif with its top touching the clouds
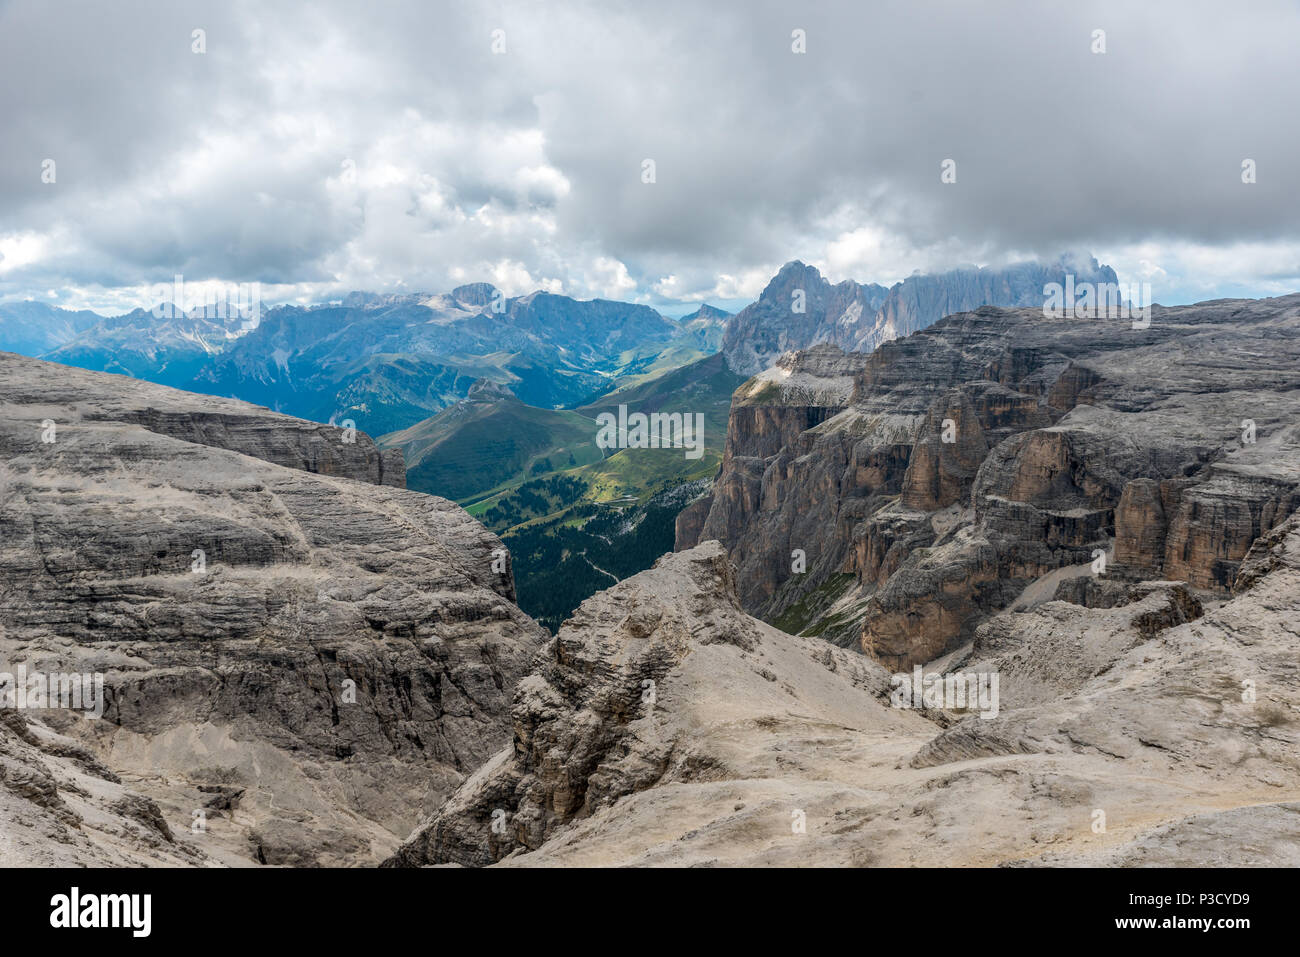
[722,260,1117,376]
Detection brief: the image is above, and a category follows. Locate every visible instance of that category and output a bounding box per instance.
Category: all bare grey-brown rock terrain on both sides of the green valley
[0,295,1300,867]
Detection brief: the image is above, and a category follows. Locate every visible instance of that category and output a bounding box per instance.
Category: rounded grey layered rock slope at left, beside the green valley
[0,354,543,863]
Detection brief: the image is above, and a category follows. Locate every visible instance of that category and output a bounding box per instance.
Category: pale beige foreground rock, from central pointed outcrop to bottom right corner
[389,515,1300,866]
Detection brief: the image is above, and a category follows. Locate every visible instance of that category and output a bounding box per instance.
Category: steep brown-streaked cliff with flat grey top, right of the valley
[679,296,1300,668]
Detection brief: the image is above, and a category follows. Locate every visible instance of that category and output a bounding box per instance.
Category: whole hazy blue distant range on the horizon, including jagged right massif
[0,257,1115,434]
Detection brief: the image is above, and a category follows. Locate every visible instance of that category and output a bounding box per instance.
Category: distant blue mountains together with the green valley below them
[0,257,1115,629]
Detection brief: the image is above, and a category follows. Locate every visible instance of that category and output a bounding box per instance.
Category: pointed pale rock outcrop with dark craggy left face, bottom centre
[389,542,926,866]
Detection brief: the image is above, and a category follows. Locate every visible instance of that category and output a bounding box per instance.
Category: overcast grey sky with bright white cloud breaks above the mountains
[0,0,1300,311]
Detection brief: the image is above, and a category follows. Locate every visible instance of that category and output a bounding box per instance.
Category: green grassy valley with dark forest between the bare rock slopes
[378,354,742,631]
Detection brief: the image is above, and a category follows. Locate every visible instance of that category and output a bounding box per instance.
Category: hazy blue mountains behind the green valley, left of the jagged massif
[38,283,707,434]
